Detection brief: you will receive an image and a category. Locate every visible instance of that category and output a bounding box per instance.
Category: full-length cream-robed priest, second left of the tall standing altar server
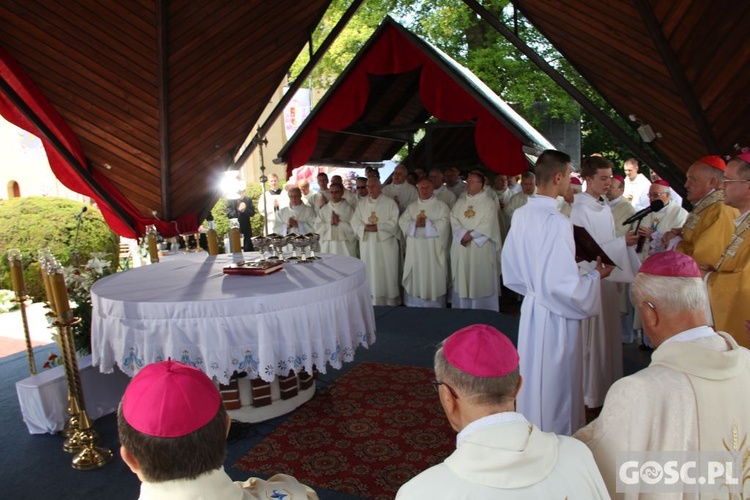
[398,178,451,307]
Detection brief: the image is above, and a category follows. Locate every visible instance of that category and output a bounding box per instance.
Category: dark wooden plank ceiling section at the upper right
[513,0,750,172]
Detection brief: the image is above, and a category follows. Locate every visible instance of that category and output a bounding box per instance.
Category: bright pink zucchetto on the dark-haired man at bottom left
[122,360,221,438]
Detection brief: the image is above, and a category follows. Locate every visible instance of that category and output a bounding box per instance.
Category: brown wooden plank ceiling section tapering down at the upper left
[0,0,330,235]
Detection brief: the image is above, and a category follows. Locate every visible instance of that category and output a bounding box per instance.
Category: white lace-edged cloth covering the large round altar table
[91,252,375,384]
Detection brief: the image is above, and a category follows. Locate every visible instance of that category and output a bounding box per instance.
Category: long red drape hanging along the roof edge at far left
[0,47,198,238]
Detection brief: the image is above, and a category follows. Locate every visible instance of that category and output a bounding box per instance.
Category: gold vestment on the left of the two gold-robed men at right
[677,190,739,266]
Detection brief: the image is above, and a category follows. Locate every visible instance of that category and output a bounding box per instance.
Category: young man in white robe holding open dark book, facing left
[570,156,641,408]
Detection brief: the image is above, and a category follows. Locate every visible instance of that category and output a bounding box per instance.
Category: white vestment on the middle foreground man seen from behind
[396,412,609,500]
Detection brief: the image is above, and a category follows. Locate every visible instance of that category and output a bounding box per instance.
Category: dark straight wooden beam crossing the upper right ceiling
[633,0,721,154]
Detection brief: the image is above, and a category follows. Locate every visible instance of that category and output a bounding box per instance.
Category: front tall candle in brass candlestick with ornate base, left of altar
[49,269,113,470]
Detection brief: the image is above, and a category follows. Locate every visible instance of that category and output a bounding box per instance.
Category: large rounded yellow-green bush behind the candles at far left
[0,196,119,301]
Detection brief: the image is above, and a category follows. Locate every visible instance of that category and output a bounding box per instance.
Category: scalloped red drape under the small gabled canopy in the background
[287,27,527,175]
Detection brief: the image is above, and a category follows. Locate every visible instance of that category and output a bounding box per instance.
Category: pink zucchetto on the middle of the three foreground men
[443,325,518,377]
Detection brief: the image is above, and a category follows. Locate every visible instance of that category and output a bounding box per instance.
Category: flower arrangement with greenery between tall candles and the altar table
[63,252,113,355]
